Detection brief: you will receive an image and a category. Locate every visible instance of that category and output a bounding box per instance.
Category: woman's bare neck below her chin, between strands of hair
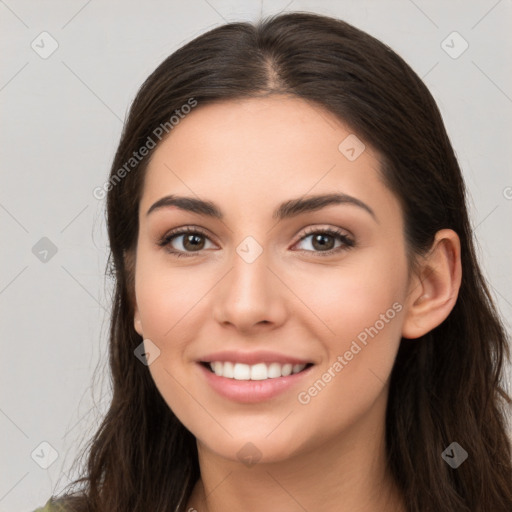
[186,388,405,512]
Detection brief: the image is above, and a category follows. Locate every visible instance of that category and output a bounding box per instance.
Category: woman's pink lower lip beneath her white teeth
[198,363,313,404]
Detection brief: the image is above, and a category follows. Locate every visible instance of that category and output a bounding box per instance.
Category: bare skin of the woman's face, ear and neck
[130,96,461,512]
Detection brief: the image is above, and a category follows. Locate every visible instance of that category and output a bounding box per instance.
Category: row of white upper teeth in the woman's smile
[206,361,306,380]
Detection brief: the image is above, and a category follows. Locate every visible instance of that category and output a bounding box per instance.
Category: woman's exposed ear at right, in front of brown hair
[402,229,462,339]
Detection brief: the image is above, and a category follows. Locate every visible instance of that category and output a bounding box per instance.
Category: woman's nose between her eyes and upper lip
[214,244,289,335]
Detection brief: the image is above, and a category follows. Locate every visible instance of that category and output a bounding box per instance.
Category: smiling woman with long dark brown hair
[35,13,512,512]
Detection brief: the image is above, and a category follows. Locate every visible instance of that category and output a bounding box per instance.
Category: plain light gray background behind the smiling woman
[0,0,512,512]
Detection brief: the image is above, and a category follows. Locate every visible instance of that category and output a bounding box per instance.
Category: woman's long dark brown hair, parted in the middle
[53,12,512,512]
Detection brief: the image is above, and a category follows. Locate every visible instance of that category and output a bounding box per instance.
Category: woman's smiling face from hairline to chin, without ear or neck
[133,96,408,462]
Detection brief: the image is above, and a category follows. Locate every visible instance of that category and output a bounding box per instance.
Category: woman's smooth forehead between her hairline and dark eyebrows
[141,95,398,223]
